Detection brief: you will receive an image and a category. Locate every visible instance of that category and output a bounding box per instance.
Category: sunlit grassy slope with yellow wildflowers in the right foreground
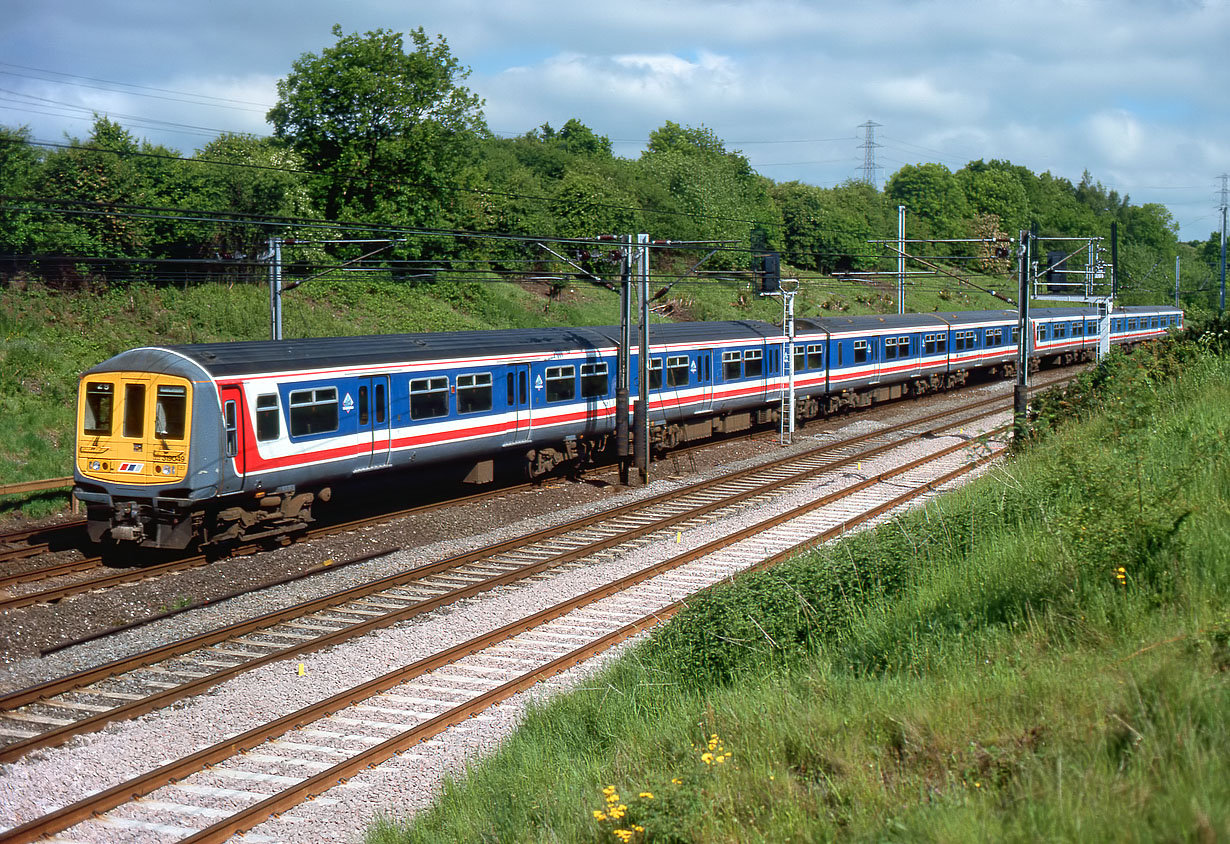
[369,326,1230,844]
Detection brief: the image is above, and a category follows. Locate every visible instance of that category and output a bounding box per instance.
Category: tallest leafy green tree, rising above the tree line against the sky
[268,26,486,234]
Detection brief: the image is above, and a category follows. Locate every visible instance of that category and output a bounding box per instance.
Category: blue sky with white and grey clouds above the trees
[0,0,1230,240]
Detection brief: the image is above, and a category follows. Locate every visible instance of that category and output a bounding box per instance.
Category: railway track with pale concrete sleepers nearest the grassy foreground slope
[0,400,1006,844]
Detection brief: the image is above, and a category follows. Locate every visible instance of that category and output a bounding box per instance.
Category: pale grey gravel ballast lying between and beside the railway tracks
[0,383,1011,843]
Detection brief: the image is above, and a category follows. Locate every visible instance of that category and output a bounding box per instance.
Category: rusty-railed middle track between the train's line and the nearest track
[0,397,1009,762]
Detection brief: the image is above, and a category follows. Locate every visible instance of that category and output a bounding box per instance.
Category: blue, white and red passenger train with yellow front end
[73,306,1183,550]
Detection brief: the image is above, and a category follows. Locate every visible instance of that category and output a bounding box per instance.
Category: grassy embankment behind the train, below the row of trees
[0,270,1002,519]
